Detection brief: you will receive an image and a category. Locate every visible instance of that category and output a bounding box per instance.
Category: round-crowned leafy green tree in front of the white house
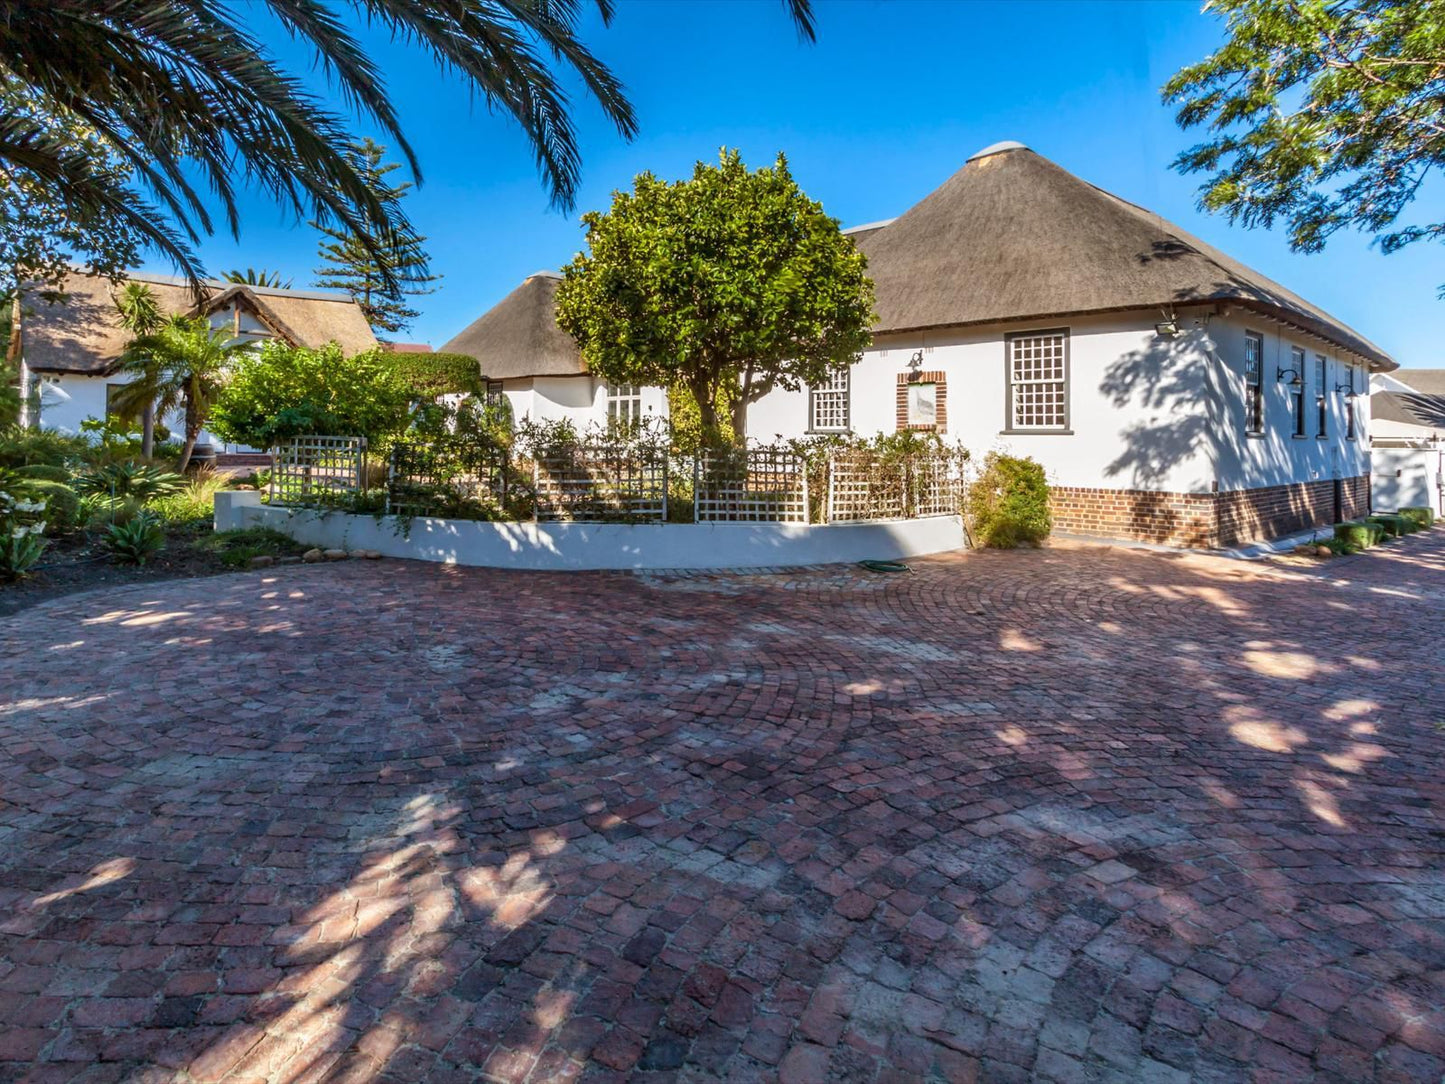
[556,150,873,442]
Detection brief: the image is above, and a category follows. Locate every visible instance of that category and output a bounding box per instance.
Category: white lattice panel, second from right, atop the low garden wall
[692,448,808,523]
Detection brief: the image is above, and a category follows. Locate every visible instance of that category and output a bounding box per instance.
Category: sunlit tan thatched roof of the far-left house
[23,273,376,376]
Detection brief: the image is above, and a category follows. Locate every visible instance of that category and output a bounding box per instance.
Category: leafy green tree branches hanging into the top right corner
[1163,0,1445,289]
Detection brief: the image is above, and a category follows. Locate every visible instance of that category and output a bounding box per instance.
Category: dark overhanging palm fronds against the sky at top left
[0,0,814,289]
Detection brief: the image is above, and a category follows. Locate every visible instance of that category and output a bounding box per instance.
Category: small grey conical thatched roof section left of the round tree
[442,272,587,380]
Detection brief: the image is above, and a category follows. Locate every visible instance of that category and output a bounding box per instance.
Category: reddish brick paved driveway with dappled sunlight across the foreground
[0,530,1445,1081]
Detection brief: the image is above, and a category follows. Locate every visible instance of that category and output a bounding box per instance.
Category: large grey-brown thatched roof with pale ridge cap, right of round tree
[854,143,1394,369]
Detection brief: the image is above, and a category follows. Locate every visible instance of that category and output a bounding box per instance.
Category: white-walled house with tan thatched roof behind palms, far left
[22,273,377,441]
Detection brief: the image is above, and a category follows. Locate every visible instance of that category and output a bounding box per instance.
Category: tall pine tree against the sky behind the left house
[311,139,441,334]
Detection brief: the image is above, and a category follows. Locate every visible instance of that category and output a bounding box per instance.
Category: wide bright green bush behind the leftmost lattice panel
[210,343,415,448]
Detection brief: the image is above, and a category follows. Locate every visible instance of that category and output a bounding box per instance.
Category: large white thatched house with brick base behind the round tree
[445,143,1397,545]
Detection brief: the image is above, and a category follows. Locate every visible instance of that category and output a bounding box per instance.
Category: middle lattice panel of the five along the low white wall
[533,445,668,523]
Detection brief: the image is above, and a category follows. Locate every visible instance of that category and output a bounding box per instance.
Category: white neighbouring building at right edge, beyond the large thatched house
[1370,369,1445,516]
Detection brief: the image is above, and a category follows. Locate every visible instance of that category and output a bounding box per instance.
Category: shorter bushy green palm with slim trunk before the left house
[117,317,251,473]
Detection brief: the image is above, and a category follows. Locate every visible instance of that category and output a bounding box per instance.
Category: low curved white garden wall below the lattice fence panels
[215,490,964,569]
